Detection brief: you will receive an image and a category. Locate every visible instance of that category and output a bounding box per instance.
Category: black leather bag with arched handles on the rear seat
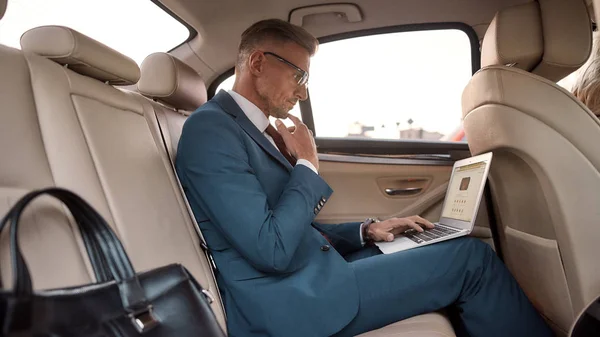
[0,188,225,337]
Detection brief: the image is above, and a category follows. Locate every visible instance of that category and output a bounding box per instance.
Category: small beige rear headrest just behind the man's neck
[137,53,207,111]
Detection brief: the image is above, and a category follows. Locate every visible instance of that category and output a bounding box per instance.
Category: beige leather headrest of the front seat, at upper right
[481,0,592,82]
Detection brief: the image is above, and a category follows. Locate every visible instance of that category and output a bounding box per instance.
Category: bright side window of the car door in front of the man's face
[309,29,472,141]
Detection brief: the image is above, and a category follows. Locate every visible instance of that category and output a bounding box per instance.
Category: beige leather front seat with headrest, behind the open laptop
[462,0,600,335]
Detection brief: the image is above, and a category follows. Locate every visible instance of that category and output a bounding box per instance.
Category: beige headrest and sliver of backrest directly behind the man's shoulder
[137,53,207,161]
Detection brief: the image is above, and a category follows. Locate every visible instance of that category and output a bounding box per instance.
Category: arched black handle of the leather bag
[0,187,156,330]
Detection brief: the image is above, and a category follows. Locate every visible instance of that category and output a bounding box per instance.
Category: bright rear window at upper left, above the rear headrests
[0,0,190,64]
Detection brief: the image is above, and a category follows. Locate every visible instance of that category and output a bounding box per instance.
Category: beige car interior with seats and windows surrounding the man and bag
[0,0,600,336]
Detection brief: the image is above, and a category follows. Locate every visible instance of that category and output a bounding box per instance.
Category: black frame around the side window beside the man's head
[208,22,481,157]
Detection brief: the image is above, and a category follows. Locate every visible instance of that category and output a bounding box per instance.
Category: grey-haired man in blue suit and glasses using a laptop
[176,20,551,337]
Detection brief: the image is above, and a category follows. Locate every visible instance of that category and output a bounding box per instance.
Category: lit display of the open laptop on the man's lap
[442,162,486,222]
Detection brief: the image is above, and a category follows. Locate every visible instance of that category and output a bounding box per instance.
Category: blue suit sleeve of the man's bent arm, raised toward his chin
[177,111,333,272]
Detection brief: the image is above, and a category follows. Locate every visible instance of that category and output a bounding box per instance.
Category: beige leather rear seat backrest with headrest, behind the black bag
[0,26,225,327]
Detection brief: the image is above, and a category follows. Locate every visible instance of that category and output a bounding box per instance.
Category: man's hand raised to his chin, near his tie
[275,114,319,170]
